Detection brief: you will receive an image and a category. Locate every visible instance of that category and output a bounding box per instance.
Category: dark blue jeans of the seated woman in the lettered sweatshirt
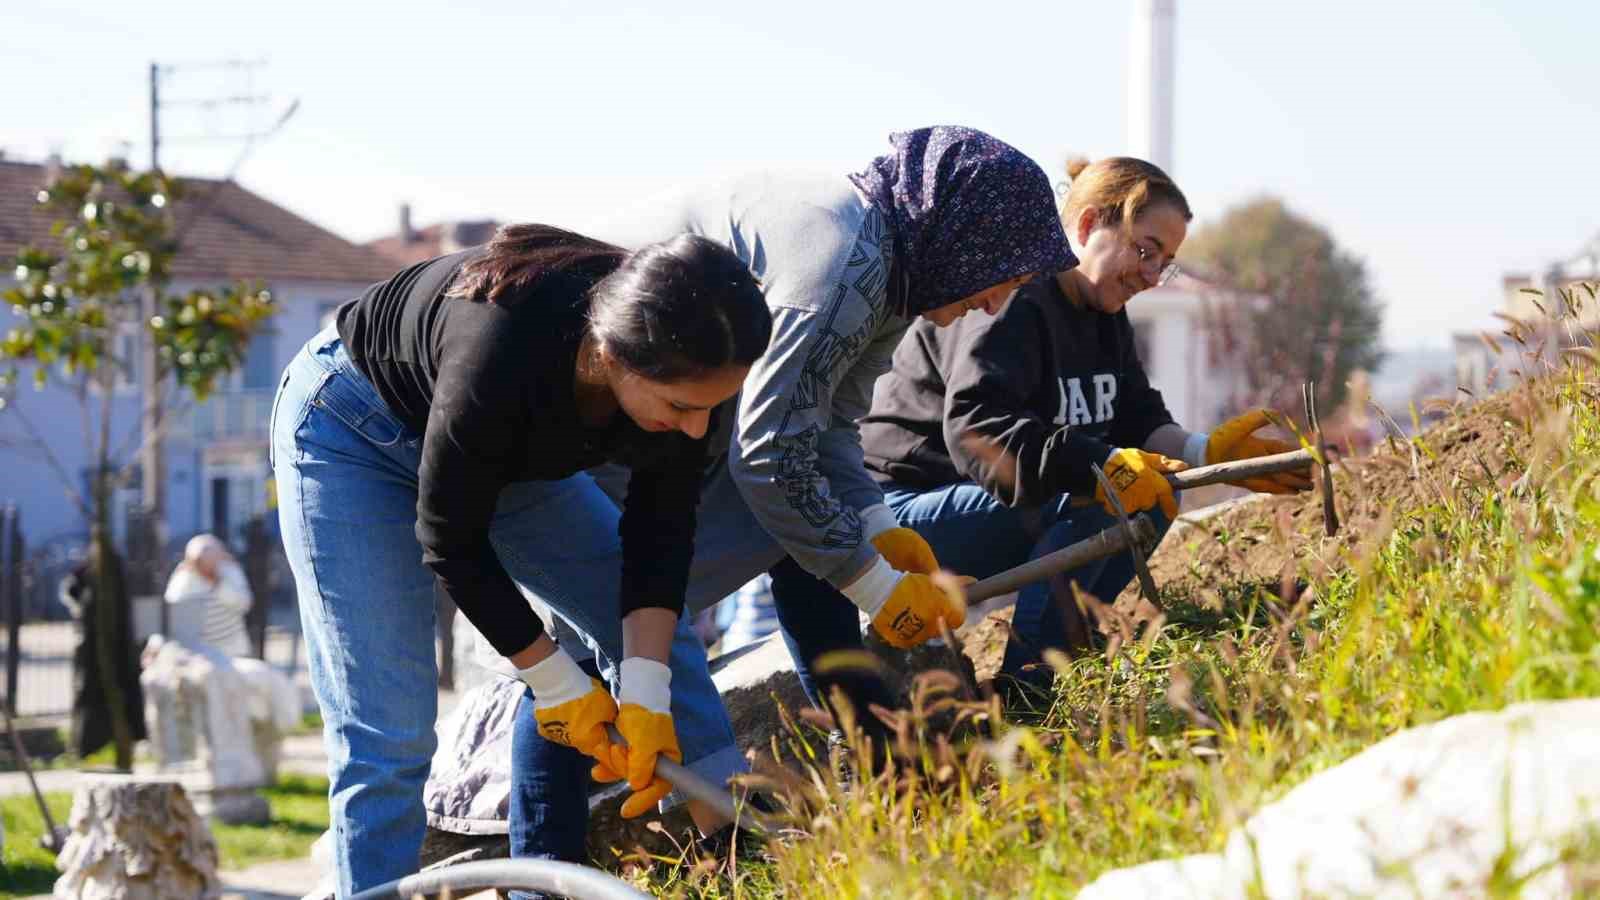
[773,482,1170,708]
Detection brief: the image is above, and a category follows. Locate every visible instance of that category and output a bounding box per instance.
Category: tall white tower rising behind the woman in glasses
[1128,0,1178,175]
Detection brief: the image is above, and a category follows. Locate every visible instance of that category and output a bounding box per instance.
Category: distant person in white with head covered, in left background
[166,535,253,658]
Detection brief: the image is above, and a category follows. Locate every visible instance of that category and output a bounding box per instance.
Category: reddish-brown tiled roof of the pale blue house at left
[0,160,395,283]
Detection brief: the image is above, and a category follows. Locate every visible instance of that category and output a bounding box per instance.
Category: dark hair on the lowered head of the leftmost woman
[589,234,773,383]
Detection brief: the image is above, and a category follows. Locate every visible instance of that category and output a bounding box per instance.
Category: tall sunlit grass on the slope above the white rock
[632,350,1600,898]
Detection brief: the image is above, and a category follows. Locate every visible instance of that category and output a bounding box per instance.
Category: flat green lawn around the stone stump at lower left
[0,775,328,897]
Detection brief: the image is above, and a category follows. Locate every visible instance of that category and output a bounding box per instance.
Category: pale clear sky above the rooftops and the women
[0,0,1600,348]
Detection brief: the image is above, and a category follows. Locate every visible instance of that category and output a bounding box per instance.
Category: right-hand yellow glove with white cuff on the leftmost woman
[590,657,683,818]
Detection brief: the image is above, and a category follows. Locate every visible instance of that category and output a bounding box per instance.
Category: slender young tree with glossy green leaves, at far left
[0,162,277,769]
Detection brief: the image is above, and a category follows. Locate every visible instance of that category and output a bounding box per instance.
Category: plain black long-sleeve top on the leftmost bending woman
[338,248,709,657]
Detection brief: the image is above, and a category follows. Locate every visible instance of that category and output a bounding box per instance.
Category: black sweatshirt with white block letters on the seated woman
[861,275,1173,506]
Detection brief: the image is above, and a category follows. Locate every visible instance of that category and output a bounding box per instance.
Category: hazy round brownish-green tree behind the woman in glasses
[1182,197,1384,410]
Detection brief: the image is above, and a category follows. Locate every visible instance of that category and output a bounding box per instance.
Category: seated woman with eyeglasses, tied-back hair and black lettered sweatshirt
[844,157,1309,687]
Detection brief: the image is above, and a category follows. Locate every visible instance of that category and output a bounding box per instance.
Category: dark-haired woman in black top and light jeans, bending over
[272,226,771,895]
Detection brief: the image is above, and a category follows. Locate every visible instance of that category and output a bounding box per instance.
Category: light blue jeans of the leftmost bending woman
[272,328,746,897]
